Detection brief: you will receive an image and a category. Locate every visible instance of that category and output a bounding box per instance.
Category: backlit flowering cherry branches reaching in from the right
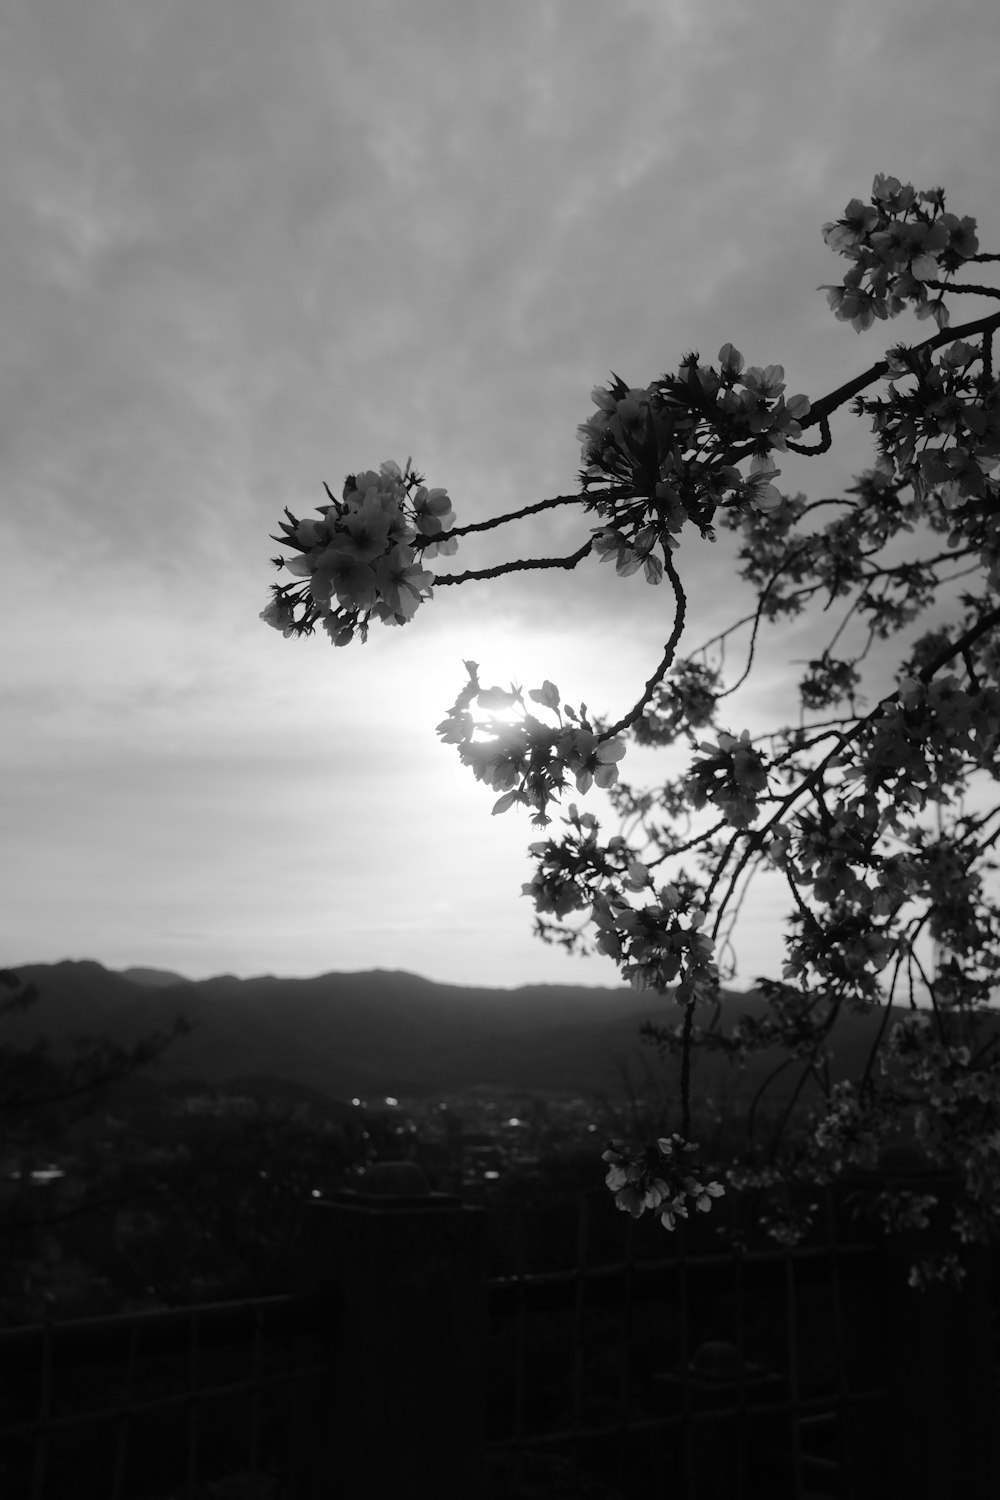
[264,174,1000,1278]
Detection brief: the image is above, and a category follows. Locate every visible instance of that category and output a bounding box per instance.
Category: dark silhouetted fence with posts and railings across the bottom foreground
[0,1176,1000,1500]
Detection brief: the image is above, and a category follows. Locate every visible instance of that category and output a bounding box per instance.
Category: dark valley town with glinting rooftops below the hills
[0,1080,665,1323]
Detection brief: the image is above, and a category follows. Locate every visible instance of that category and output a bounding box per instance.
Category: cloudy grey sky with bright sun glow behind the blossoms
[0,0,1000,987]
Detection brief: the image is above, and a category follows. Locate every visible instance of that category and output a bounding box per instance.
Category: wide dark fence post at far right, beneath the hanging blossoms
[852,1172,1000,1500]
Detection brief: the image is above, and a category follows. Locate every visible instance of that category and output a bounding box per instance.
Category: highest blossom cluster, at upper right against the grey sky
[822,173,979,333]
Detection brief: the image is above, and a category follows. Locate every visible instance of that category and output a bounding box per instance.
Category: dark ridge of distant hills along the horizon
[0,960,929,1098]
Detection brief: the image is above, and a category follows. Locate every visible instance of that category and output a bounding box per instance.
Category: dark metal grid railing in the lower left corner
[0,1296,336,1500]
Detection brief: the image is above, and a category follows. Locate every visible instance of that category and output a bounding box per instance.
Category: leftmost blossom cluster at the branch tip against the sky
[261,461,457,647]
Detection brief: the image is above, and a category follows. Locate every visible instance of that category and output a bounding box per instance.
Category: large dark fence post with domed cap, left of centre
[292,1163,487,1500]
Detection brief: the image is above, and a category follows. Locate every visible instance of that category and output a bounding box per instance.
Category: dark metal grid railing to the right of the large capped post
[487,1200,888,1500]
